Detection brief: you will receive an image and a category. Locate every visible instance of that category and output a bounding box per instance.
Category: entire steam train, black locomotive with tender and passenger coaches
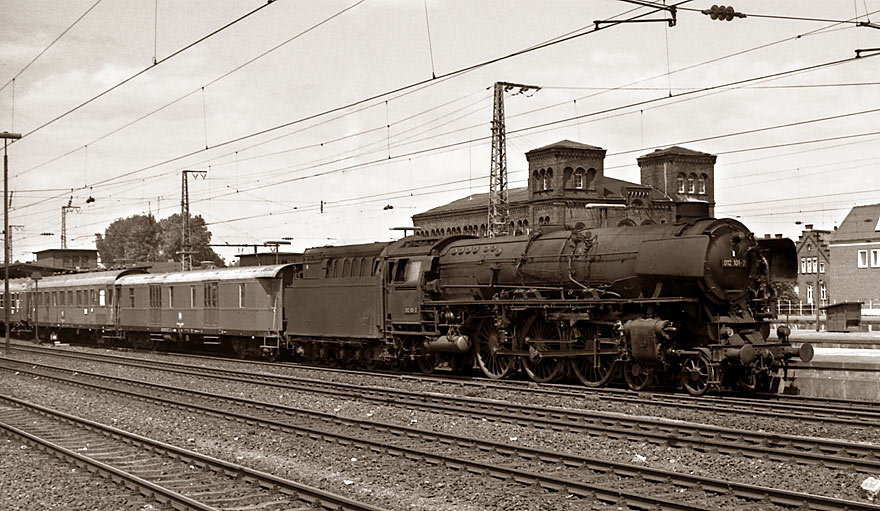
[3,218,812,395]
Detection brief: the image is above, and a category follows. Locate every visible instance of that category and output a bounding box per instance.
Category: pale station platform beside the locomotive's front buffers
[779,344,880,402]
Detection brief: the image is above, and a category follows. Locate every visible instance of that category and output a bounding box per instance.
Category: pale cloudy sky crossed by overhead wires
[0,0,880,263]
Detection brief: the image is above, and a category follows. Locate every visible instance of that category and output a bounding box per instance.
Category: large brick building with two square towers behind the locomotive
[412,140,716,236]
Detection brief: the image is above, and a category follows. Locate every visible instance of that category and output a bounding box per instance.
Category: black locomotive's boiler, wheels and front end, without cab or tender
[412,219,812,394]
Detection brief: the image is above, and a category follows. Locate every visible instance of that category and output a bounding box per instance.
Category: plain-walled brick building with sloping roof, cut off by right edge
[829,204,880,309]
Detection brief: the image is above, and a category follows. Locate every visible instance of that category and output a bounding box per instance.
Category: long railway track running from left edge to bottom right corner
[0,361,880,511]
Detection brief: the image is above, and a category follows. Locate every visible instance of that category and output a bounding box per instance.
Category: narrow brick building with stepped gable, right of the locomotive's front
[794,224,832,306]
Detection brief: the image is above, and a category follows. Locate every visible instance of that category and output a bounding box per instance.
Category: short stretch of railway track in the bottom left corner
[0,396,382,511]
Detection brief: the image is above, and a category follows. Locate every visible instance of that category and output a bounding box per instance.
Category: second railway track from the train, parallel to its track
[5,352,880,473]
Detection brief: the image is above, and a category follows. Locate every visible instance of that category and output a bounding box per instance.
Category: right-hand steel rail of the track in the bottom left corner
[0,395,387,511]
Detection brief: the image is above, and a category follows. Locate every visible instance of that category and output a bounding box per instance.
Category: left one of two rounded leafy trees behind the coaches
[95,215,159,266]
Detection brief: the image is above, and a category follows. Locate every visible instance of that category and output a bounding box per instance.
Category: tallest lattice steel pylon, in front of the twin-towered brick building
[486,82,541,238]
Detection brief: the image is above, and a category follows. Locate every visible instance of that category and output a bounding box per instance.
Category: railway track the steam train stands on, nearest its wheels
[8,345,880,428]
